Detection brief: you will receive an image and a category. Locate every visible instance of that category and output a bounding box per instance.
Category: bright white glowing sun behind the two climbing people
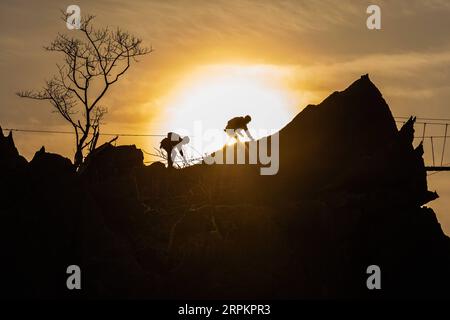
[156,64,300,153]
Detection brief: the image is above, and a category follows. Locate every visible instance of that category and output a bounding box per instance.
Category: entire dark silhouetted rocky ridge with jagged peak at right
[0,76,450,299]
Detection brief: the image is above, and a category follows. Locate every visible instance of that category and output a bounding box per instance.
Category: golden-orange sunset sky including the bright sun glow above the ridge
[0,0,450,234]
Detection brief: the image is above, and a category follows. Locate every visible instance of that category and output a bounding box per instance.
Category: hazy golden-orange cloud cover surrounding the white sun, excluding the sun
[0,0,450,152]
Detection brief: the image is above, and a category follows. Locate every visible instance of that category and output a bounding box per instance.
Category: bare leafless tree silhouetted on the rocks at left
[17,14,153,167]
